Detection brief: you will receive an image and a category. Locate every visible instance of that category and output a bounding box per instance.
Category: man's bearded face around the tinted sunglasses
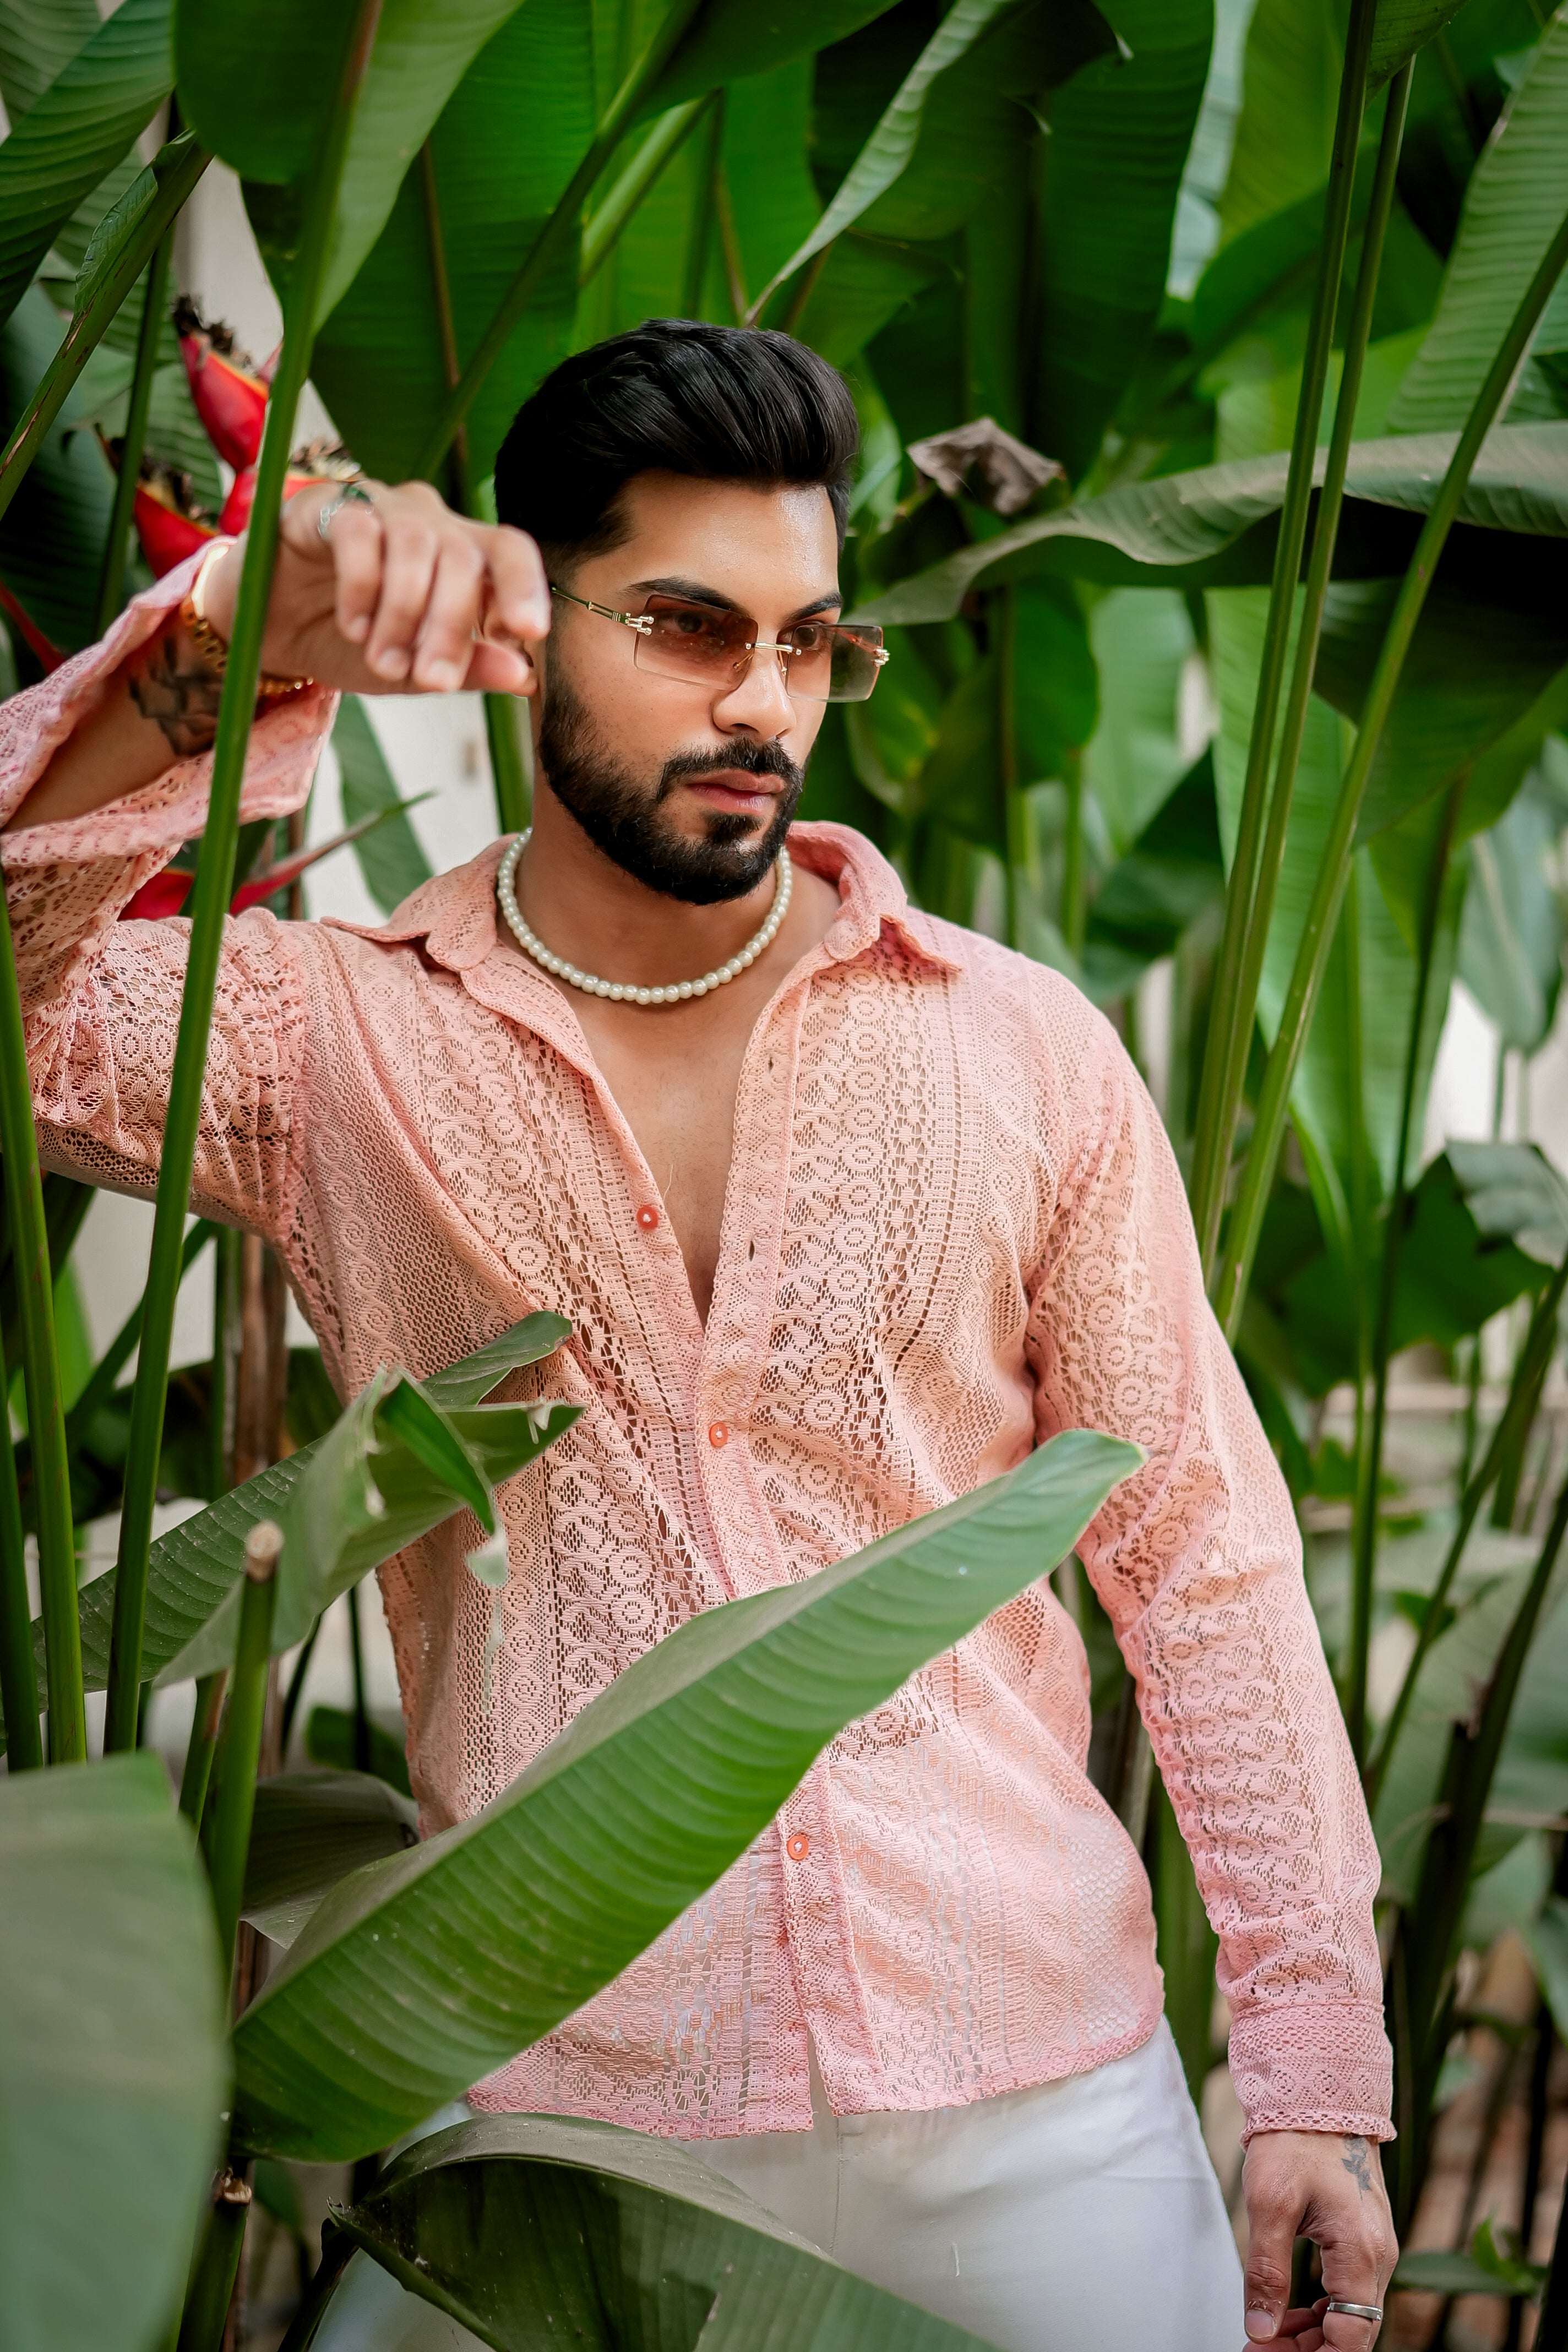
[538,473,839,906]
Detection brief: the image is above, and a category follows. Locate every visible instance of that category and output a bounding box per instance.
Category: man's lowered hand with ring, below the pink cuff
[1241,2131,1399,2352]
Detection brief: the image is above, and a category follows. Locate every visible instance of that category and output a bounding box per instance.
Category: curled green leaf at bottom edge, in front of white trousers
[327,2115,1006,2352]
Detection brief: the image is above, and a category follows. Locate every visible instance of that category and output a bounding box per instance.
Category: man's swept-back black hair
[496,318,861,555]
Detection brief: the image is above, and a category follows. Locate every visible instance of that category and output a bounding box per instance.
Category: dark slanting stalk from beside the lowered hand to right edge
[1394,1482,1568,2230]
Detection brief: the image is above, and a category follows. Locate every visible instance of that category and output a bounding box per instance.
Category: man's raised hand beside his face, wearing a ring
[202,482,550,694]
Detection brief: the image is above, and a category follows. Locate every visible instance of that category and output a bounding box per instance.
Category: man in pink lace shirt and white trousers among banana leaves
[0,322,1394,2352]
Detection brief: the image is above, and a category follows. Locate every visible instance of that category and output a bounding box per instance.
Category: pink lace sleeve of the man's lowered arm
[1030,1016,1392,2141]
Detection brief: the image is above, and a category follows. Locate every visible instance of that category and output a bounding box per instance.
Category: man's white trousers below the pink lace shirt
[317,2018,1246,2352]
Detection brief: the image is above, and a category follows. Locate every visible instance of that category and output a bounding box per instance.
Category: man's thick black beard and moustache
[538,677,807,906]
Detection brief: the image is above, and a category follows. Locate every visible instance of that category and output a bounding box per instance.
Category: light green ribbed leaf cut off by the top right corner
[1389,9,1568,433]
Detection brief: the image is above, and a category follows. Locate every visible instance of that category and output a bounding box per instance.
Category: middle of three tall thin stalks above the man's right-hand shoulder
[1204,59,1415,1263]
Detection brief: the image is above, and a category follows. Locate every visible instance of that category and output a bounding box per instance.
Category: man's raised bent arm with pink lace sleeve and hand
[0,484,548,1233]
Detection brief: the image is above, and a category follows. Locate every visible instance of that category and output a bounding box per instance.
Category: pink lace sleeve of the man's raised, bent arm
[0,560,334,1235]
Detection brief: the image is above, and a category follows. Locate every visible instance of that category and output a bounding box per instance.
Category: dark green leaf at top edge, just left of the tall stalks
[1025,0,1213,482]
